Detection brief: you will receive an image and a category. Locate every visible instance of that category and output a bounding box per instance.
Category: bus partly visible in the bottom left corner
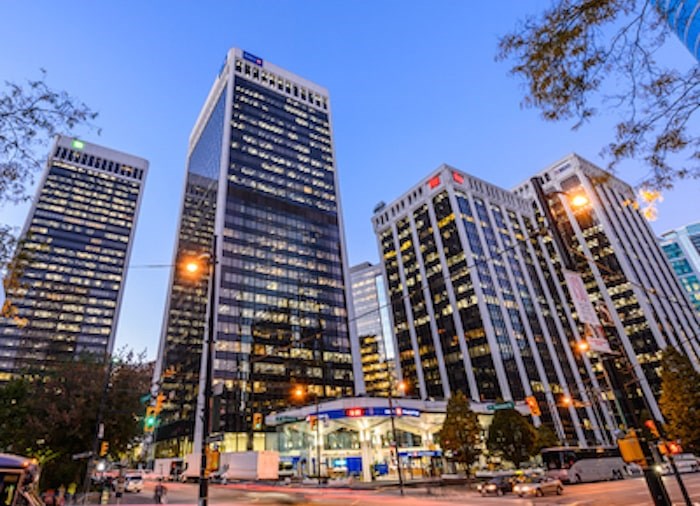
[0,453,42,506]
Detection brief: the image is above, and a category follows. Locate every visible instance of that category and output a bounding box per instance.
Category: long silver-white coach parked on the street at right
[540,446,633,483]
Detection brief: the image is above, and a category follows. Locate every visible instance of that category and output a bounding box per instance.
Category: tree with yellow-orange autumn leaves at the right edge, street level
[659,346,700,453]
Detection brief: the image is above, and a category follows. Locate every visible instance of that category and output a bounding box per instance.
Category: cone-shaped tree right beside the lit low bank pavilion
[438,390,481,476]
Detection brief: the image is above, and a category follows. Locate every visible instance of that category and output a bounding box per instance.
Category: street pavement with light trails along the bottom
[94,473,700,506]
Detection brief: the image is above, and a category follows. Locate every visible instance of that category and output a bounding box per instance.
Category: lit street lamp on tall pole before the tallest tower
[184,234,217,506]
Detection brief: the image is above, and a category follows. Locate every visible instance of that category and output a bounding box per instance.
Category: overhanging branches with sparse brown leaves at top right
[498,0,700,189]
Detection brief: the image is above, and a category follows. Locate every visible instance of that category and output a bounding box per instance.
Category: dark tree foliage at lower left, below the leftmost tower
[0,352,151,486]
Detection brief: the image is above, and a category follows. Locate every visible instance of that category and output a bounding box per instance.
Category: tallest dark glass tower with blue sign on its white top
[155,49,353,454]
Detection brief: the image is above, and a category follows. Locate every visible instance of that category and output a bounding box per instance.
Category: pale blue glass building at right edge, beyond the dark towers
[661,223,700,315]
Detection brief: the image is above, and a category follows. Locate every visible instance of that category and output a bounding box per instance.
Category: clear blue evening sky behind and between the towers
[0,0,700,359]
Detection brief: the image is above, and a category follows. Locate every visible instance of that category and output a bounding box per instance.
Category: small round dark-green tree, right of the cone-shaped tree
[486,409,537,467]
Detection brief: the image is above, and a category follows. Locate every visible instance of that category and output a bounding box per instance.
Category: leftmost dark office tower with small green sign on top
[0,136,148,380]
